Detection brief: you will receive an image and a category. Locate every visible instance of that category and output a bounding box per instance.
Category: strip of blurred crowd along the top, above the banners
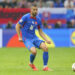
[0,0,75,8]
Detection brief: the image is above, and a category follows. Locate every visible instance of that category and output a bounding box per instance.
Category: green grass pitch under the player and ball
[0,48,75,75]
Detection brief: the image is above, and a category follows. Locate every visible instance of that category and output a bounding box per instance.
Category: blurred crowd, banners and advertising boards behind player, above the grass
[0,0,75,47]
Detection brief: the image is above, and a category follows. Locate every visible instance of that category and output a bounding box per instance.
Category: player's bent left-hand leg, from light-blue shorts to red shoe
[24,40,38,71]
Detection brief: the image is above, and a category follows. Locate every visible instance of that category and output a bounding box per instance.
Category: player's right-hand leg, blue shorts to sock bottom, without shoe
[34,38,49,68]
